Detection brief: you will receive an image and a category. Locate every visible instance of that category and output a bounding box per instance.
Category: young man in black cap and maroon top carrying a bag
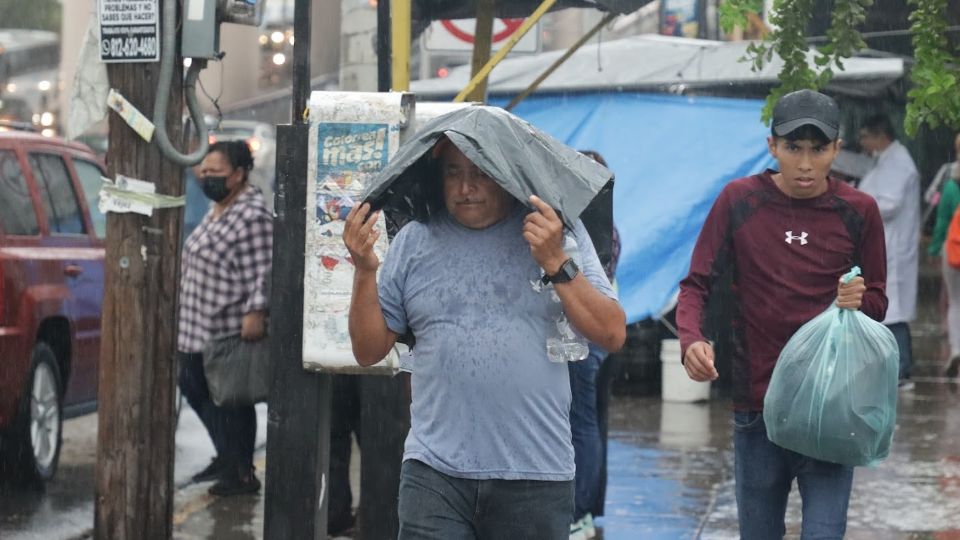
[677,90,887,540]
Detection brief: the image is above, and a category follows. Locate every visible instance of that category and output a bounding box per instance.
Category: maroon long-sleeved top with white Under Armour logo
[677,170,887,411]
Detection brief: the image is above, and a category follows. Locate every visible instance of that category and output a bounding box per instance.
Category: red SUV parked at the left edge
[0,131,106,481]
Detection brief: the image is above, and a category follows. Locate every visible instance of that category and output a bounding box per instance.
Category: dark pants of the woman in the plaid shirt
[177,352,257,473]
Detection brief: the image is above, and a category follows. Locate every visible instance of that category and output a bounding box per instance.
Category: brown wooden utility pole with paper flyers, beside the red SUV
[94,0,183,540]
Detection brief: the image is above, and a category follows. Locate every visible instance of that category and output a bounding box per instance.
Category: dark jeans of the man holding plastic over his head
[398,460,573,540]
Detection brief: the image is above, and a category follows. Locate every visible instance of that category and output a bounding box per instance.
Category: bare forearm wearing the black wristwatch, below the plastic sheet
[554,274,627,352]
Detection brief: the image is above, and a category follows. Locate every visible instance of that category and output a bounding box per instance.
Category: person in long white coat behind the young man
[860,115,920,387]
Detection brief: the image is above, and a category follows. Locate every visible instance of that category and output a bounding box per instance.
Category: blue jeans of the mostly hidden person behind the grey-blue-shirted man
[567,345,607,520]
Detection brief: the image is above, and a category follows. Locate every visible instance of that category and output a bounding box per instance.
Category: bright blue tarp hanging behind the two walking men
[493,93,774,322]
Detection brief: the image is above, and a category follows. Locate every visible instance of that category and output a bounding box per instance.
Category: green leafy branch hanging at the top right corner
[904,0,960,136]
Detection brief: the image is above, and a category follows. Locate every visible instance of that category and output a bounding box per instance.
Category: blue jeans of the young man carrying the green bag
[733,412,853,540]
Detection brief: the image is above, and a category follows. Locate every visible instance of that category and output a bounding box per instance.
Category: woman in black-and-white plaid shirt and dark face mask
[177,141,273,496]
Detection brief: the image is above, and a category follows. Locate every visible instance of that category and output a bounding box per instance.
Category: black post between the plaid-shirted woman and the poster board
[263,0,331,540]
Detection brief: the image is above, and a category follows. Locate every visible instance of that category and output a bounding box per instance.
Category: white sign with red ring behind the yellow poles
[423,19,540,53]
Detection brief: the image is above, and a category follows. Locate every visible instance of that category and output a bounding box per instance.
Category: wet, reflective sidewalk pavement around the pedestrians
[175,378,960,540]
